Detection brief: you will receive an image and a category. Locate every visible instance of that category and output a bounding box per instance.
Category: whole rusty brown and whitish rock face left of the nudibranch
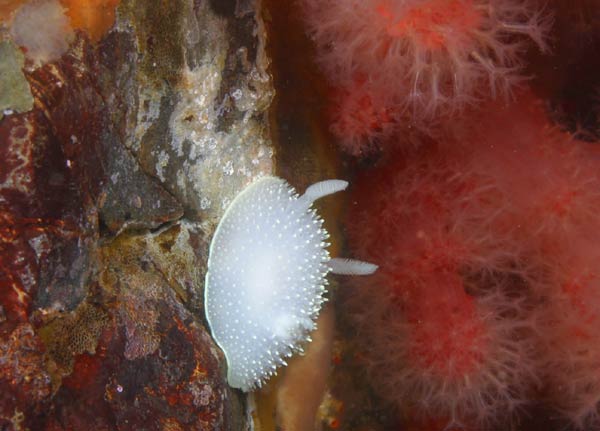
[0,0,273,430]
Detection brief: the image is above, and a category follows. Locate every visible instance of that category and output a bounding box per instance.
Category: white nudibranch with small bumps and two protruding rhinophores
[204,177,377,391]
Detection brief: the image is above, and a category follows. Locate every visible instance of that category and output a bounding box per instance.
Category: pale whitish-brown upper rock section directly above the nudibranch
[101,0,273,223]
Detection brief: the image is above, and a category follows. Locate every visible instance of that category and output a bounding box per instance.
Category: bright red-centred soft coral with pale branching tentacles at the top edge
[298,0,549,148]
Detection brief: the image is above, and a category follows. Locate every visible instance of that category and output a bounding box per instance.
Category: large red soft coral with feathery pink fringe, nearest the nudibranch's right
[344,151,537,429]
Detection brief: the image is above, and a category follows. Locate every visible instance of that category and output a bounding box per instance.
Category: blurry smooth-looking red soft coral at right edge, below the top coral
[455,92,600,256]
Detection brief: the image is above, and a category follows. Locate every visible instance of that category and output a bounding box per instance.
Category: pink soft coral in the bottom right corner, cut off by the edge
[543,241,600,430]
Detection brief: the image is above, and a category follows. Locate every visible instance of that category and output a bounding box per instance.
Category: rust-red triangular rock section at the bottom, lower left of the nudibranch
[17,235,242,430]
